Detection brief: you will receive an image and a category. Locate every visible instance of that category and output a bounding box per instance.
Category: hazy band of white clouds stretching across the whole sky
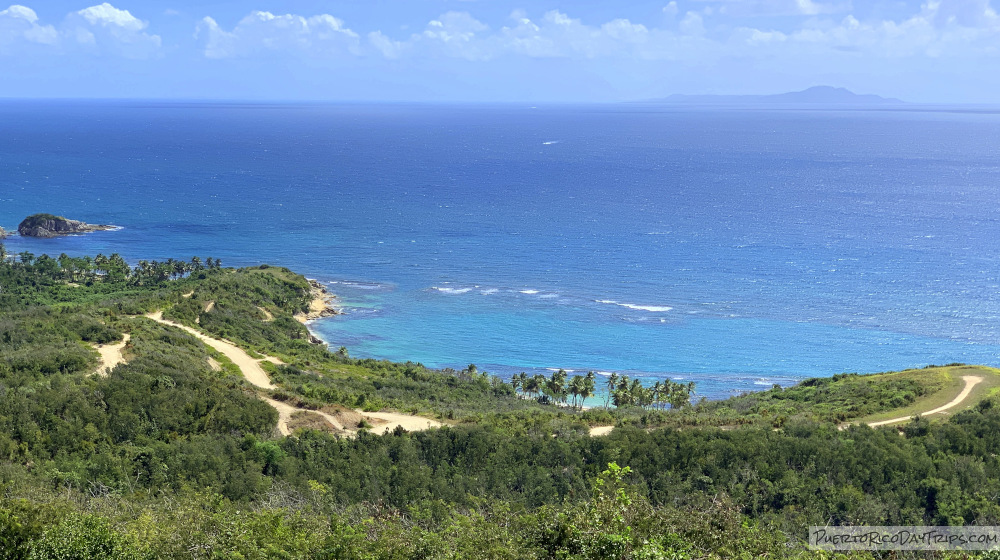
[0,0,1000,99]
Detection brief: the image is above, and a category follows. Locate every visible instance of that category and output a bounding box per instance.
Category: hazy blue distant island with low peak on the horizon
[646,86,903,105]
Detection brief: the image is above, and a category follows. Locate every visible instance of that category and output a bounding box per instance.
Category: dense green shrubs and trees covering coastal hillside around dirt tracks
[0,247,1000,559]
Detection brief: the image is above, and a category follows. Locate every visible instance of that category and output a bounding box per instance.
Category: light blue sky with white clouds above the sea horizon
[0,0,1000,103]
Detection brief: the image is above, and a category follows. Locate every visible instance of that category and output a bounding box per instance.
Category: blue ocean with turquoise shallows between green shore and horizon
[0,101,1000,398]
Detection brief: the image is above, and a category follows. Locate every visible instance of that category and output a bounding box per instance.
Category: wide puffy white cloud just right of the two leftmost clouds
[197,11,361,58]
